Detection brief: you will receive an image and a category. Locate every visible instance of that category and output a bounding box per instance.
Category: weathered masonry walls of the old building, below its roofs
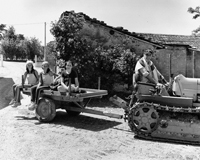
[81,22,196,80]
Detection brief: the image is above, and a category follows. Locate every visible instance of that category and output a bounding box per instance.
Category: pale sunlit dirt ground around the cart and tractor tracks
[0,62,200,160]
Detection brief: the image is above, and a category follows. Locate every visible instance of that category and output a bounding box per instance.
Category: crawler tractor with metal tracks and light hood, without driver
[111,75,200,144]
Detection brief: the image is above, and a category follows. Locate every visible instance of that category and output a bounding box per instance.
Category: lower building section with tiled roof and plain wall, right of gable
[138,33,200,78]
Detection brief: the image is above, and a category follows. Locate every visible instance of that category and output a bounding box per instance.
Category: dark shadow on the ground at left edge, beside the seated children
[0,77,14,109]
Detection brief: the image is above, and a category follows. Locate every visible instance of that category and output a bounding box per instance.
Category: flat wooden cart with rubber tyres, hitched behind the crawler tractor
[36,88,123,122]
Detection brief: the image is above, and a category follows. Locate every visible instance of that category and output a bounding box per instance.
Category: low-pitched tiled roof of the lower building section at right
[137,33,200,51]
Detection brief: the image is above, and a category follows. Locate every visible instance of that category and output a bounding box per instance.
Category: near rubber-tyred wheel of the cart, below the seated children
[35,98,56,122]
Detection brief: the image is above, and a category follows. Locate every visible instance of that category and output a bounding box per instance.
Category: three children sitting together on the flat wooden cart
[9,61,79,110]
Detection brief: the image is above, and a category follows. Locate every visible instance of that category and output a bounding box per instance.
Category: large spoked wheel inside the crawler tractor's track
[128,103,159,134]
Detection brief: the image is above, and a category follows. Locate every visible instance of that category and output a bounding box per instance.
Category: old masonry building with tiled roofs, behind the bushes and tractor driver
[61,11,200,79]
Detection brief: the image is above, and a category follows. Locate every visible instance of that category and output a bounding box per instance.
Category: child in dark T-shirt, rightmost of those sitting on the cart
[58,60,79,93]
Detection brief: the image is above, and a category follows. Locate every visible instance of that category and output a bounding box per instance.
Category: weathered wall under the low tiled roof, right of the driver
[153,45,200,80]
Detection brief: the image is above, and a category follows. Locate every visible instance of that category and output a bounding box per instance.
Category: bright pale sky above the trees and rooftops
[0,0,200,45]
